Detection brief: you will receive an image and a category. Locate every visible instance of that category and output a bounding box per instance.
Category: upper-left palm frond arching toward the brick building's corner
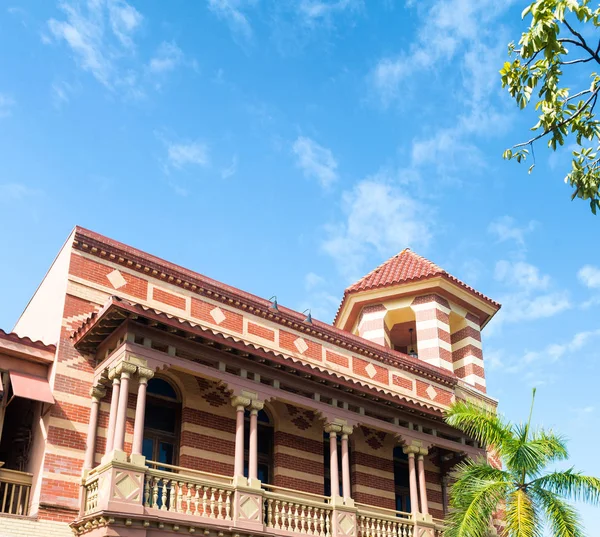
[446,401,514,456]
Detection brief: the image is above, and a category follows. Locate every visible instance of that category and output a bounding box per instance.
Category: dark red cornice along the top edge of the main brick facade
[73,227,456,386]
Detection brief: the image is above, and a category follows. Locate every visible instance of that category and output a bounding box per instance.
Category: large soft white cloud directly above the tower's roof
[322,175,433,278]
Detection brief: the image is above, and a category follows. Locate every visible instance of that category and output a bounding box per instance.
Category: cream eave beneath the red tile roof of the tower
[335,275,500,331]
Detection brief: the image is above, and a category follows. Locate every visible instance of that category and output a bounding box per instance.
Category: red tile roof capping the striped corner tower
[334,248,500,323]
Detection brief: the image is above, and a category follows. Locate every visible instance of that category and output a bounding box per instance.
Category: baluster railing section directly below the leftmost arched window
[144,461,233,520]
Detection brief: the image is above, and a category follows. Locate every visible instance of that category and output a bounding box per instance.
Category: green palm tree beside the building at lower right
[444,389,600,537]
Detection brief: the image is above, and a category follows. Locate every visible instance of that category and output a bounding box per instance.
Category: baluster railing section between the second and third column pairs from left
[263,483,331,537]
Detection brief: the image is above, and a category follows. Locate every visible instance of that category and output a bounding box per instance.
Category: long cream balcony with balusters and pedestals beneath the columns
[72,460,443,537]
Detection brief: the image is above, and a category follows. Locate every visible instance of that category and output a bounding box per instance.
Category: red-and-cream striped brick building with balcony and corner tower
[0,227,500,537]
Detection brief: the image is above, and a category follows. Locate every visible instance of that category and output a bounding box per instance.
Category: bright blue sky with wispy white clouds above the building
[0,0,600,536]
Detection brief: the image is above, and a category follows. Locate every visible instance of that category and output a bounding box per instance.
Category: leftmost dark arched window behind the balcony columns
[142,377,181,464]
